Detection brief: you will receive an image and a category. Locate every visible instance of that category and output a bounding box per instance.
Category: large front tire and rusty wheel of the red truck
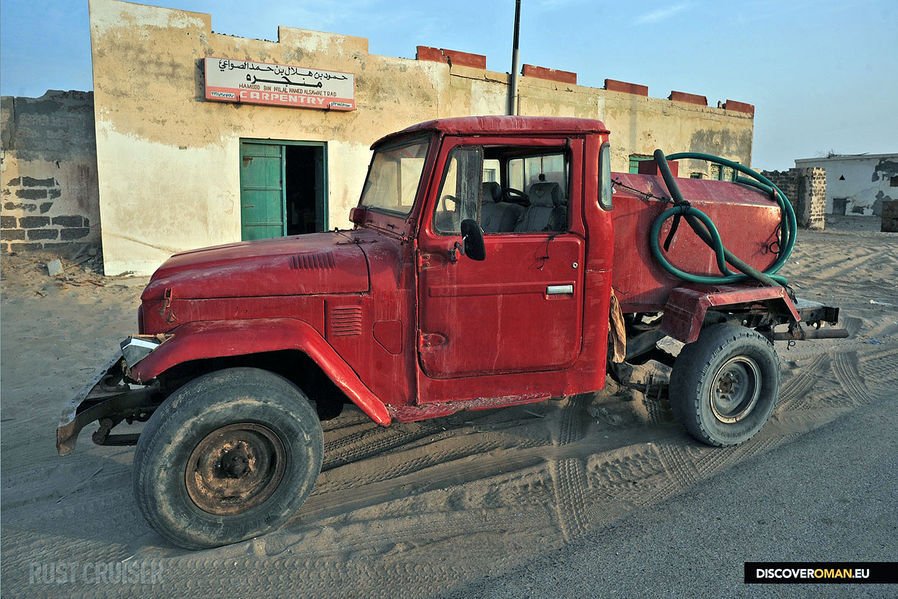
[133,368,324,549]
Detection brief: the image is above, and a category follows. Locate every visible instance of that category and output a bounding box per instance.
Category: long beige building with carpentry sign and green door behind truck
[72,0,754,274]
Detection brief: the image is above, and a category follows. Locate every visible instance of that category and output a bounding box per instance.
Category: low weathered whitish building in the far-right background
[795,154,898,216]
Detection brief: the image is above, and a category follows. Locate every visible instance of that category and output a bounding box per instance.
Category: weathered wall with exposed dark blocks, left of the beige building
[0,91,100,252]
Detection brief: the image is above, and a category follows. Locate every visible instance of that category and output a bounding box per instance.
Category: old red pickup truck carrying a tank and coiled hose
[57,116,843,548]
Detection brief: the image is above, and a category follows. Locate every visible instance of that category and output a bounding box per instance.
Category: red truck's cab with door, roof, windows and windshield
[352,117,613,420]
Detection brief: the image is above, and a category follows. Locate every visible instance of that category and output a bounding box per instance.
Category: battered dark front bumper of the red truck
[56,337,161,455]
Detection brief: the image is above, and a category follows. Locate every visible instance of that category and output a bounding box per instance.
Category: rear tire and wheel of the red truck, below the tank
[670,324,780,447]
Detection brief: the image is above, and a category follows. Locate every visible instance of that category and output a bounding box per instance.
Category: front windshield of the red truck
[361,139,429,216]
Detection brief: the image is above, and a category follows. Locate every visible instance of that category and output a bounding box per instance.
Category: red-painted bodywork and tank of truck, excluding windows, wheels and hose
[131,116,789,425]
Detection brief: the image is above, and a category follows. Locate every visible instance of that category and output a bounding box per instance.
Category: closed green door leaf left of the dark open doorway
[240,142,287,241]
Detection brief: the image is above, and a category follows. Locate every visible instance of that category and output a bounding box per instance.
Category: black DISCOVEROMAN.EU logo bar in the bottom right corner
[745,562,898,584]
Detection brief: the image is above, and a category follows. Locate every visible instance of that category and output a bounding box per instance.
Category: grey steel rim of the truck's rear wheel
[709,356,761,424]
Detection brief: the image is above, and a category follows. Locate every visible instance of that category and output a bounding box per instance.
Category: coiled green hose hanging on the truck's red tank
[649,150,798,286]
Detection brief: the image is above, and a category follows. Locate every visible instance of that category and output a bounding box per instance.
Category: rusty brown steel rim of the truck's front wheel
[185,422,287,516]
